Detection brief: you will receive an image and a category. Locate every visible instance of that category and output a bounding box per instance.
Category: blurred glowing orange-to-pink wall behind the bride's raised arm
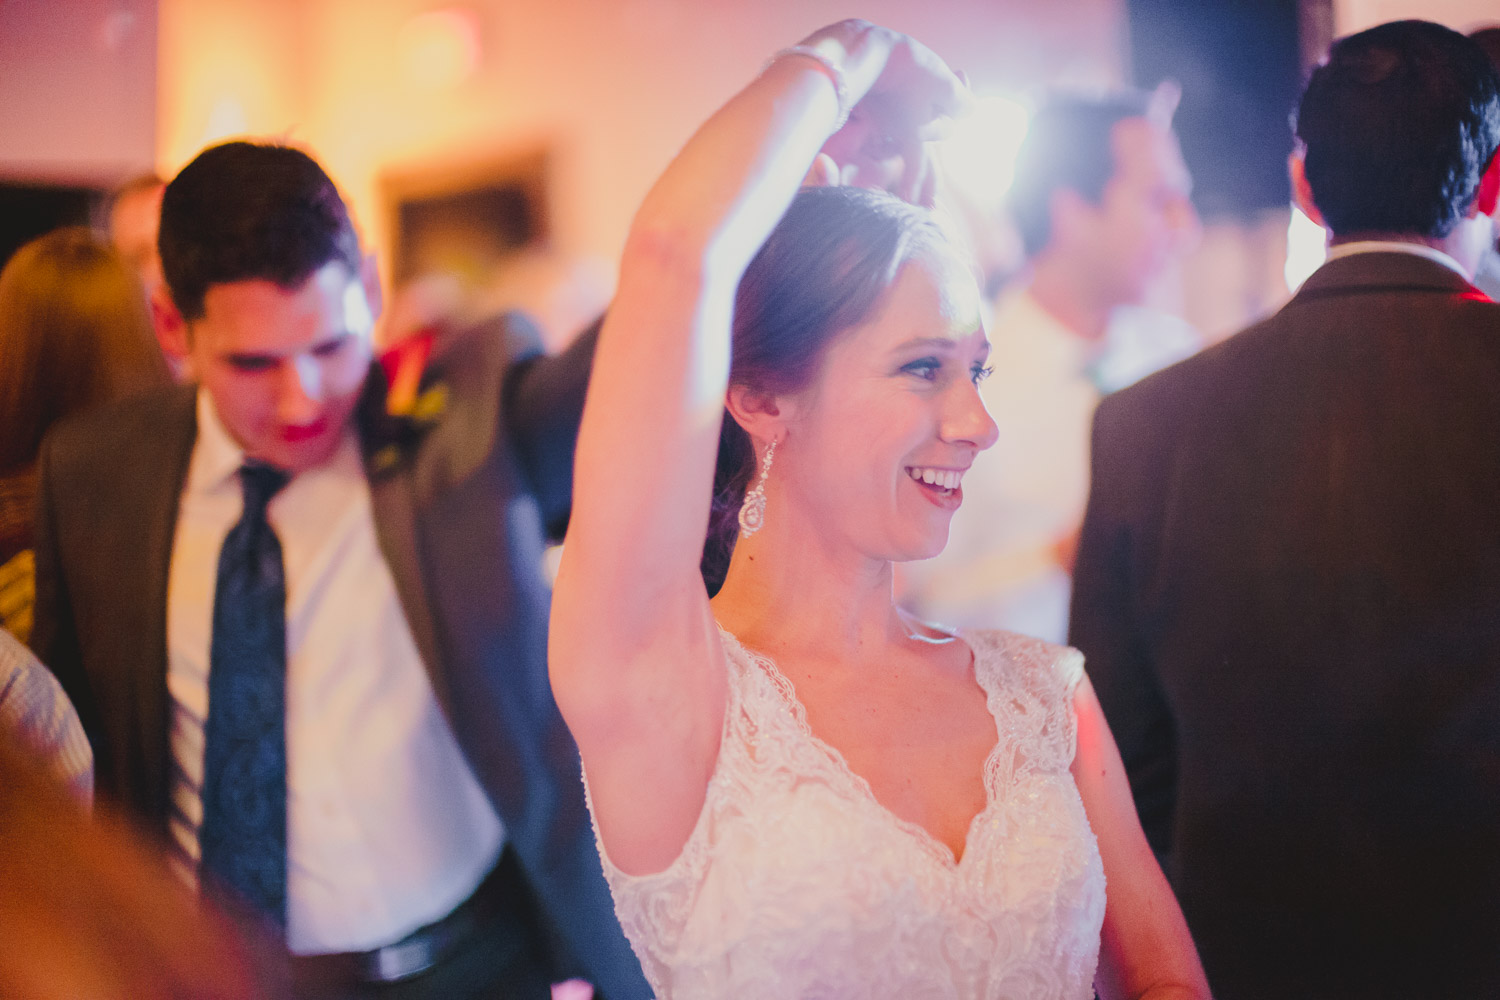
[158,0,1124,281]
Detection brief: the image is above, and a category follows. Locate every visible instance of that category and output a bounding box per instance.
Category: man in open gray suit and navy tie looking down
[26,142,647,997]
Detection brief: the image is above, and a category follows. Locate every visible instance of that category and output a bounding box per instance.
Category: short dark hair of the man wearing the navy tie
[158,142,360,321]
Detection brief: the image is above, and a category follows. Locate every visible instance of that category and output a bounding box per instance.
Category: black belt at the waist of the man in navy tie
[291,847,525,985]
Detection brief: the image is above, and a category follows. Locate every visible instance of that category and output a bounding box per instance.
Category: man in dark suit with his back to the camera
[1071,21,1500,1000]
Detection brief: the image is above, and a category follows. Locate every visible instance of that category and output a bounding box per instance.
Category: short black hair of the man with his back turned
[1295,21,1500,238]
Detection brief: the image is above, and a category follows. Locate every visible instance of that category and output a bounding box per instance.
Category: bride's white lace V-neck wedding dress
[596,631,1104,1000]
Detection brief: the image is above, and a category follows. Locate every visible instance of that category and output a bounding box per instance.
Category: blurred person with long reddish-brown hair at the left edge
[0,228,168,642]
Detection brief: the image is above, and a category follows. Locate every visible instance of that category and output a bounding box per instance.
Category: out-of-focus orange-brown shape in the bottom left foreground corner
[0,724,281,1000]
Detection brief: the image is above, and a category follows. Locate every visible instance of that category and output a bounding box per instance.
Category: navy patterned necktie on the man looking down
[198,463,288,928]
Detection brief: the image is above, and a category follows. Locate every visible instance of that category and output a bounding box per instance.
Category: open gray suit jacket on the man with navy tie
[33,318,648,999]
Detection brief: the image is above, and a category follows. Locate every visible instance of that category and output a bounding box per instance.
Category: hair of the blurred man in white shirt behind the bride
[1010,90,1151,256]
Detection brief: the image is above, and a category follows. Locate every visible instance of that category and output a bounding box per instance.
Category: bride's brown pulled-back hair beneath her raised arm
[702,187,950,594]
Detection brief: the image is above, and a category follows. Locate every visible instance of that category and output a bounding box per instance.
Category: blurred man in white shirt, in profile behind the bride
[903,90,1200,642]
